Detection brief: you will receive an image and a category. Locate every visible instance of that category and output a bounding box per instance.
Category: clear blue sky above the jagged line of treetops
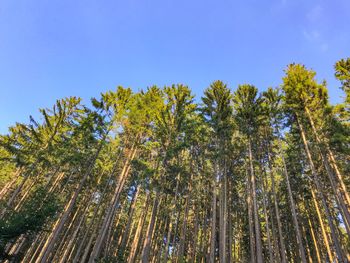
[0,0,350,133]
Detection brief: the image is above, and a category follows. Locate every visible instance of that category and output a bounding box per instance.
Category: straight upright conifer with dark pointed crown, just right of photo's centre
[202,81,232,262]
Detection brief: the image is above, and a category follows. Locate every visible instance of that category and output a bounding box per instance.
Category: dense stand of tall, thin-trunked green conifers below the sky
[0,58,350,263]
